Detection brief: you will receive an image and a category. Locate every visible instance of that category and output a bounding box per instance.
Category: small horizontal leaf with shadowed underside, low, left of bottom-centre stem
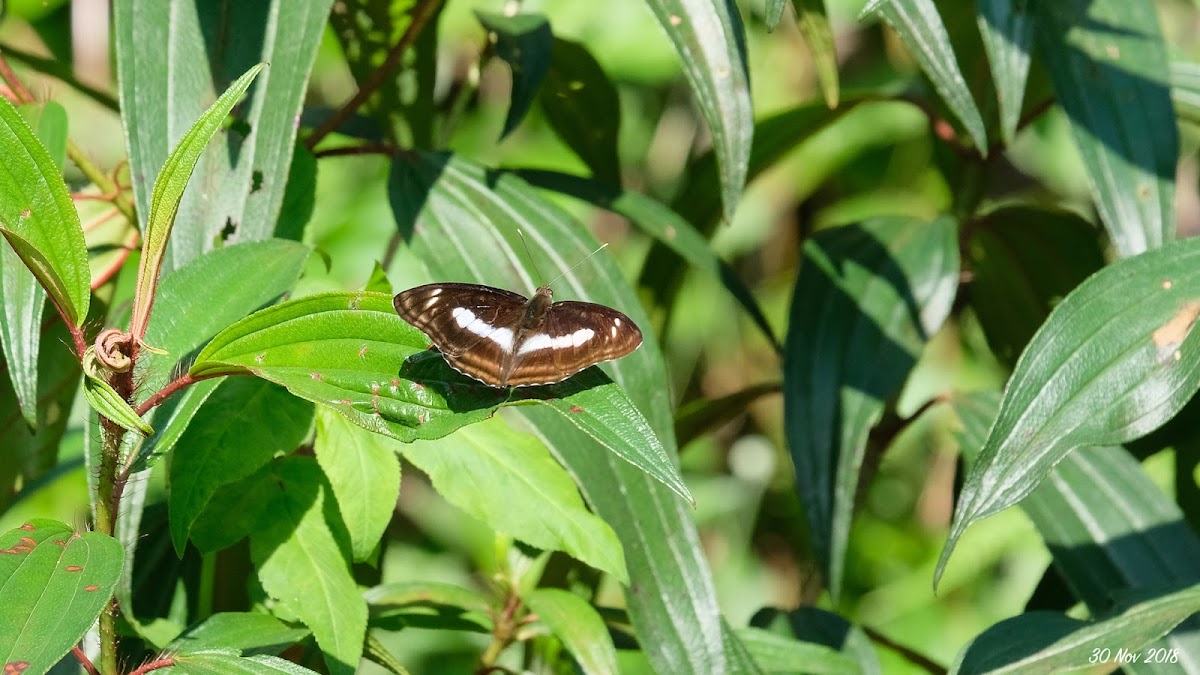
[362,581,493,633]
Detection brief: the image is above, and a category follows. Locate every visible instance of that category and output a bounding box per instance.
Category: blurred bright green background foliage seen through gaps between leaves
[0,0,1200,673]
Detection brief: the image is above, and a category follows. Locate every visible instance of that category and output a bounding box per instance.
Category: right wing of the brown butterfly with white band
[503,300,642,387]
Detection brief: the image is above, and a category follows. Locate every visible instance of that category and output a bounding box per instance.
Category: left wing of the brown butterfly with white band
[392,283,527,387]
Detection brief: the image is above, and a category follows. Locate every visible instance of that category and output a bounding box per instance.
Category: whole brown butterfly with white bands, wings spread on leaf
[392,283,642,388]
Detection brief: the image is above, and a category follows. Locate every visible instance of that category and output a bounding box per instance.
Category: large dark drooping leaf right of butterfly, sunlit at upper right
[784,216,959,602]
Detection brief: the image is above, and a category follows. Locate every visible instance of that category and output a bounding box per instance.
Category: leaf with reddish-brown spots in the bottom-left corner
[0,521,125,673]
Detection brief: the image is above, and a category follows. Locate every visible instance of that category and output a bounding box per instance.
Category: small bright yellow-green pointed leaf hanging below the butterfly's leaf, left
[313,407,400,562]
